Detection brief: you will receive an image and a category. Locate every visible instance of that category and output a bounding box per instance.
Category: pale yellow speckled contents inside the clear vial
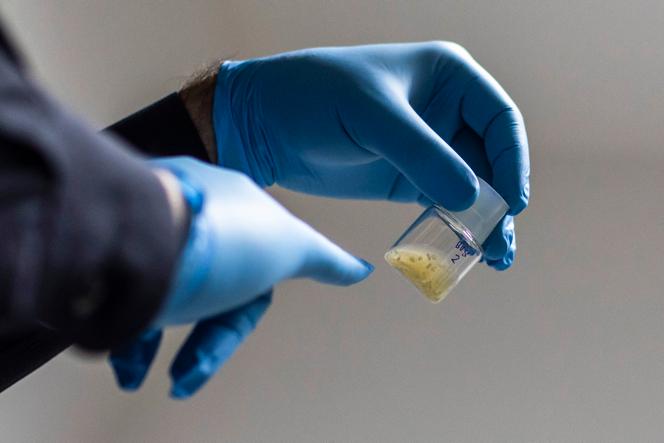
[385,245,454,303]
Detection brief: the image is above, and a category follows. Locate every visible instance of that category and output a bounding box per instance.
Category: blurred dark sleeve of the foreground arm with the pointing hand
[0,54,184,349]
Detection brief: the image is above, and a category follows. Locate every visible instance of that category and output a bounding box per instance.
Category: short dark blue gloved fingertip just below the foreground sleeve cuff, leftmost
[109,329,162,391]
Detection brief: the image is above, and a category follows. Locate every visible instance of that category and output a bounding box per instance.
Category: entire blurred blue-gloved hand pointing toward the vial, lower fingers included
[110,157,373,398]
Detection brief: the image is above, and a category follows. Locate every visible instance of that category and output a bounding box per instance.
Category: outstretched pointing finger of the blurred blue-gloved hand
[293,226,374,286]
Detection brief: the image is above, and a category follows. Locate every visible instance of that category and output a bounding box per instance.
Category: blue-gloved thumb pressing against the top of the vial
[357,96,479,211]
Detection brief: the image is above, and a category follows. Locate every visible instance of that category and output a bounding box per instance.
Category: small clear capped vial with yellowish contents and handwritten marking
[385,178,508,303]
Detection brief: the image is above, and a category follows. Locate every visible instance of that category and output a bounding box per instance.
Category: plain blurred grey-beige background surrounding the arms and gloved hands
[0,0,664,442]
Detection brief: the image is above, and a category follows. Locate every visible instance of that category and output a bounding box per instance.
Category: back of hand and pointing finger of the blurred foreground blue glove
[151,157,372,326]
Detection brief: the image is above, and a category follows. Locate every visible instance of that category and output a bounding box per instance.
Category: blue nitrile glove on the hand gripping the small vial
[213,42,529,269]
